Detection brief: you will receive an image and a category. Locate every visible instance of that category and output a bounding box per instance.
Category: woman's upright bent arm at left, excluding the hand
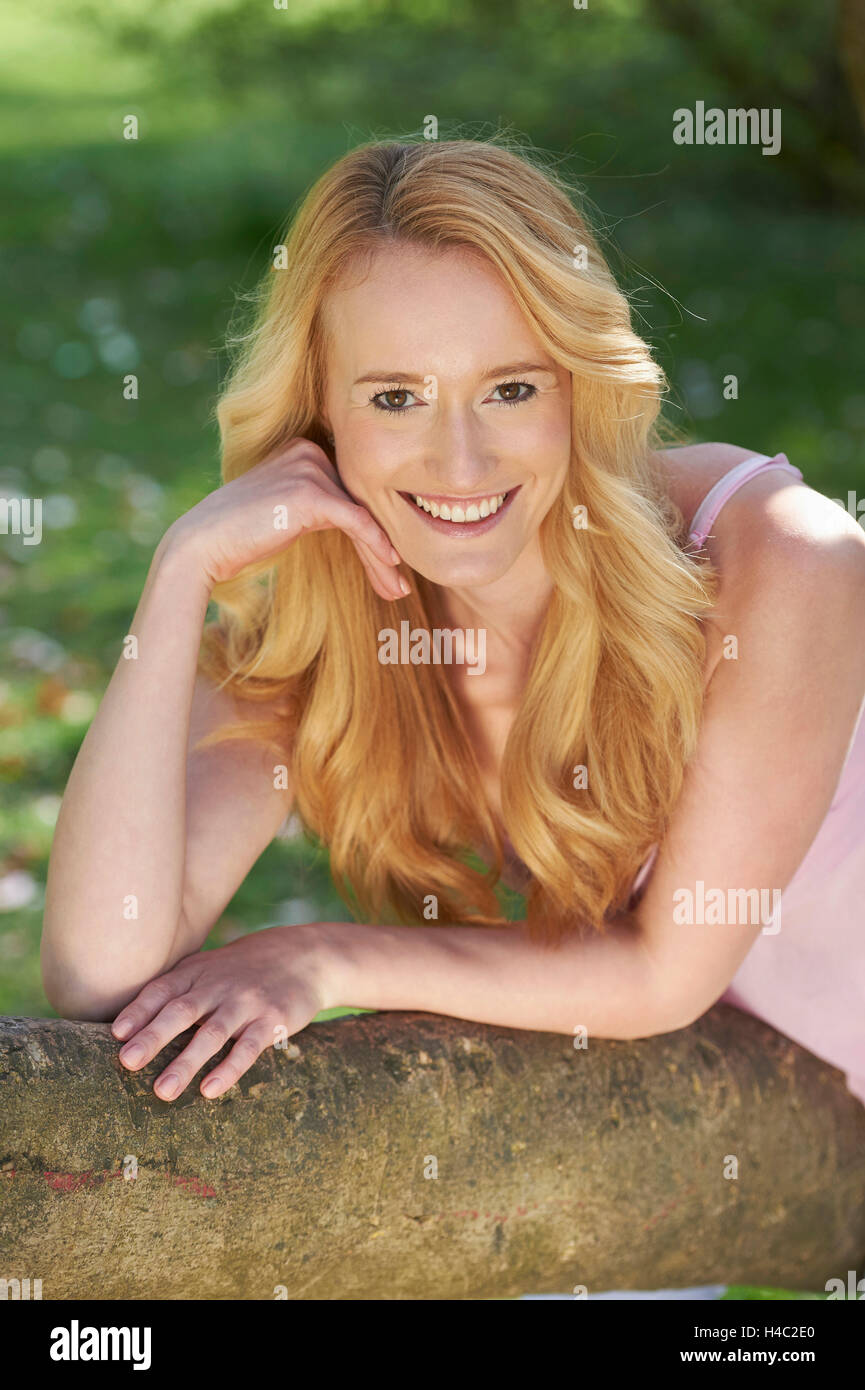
[42,543,288,1017]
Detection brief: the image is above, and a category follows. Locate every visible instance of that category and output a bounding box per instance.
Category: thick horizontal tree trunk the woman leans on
[0,1005,865,1300]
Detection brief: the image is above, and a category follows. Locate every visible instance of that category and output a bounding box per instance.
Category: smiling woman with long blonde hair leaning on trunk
[43,140,865,1101]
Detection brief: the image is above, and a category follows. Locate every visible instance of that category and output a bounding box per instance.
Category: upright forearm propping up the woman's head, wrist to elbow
[42,530,209,1011]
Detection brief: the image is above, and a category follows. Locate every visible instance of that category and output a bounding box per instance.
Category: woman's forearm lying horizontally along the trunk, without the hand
[327,915,684,1038]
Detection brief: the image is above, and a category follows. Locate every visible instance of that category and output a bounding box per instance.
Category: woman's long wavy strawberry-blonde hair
[200,139,715,941]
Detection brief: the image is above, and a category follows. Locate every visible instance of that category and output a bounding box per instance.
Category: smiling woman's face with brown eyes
[324,246,570,587]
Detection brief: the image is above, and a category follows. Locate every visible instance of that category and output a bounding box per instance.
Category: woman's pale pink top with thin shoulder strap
[631,453,865,1104]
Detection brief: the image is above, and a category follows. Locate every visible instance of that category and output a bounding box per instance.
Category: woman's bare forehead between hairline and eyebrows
[324,243,538,374]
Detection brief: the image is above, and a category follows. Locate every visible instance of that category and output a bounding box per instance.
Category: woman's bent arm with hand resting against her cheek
[42,438,403,1019]
